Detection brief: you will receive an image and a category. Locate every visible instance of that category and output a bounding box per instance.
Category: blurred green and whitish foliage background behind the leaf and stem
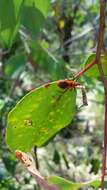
[0,0,106,190]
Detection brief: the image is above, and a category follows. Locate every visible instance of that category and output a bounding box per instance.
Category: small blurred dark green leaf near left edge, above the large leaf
[5,53,26,77]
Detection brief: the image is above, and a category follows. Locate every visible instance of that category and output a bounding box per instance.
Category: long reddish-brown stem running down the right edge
[95,0,107,190]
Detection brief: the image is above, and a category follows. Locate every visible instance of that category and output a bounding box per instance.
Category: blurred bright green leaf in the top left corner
[0,0,22,48]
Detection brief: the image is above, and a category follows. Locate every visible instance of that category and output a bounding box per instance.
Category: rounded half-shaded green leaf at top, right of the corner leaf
[21,0,50,36]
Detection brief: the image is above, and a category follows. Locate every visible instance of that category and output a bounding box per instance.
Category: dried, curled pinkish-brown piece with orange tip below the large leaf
[16,150,59,190]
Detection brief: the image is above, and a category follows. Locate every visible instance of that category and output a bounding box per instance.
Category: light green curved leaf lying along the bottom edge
[47,176,101,190]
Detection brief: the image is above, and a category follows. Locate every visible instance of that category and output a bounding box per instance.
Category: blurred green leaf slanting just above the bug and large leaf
[31,42,66,80]
